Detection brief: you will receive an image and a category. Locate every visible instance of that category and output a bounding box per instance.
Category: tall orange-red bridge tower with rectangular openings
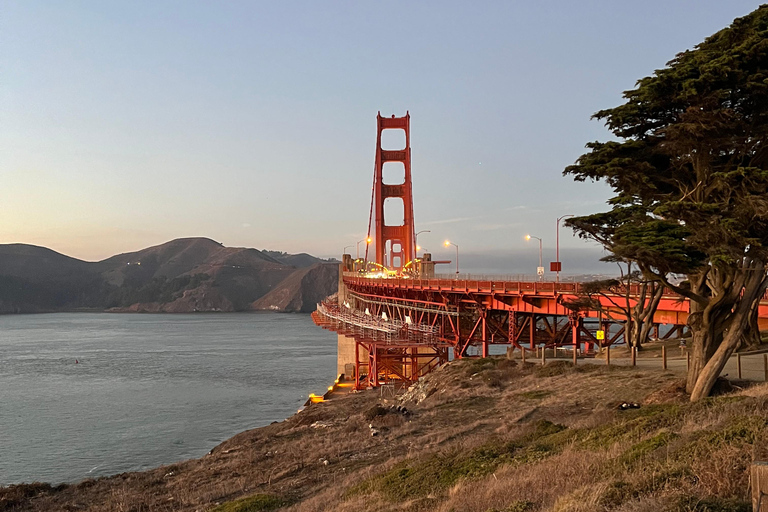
[373,112,416,270]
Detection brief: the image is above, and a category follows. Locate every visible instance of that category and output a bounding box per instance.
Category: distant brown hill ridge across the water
[0,238,338,313]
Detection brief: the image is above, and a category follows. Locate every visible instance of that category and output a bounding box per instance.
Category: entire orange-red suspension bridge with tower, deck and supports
[312,113,768,389]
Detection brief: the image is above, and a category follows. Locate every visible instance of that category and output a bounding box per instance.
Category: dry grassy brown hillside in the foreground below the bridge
[0,358,768,512]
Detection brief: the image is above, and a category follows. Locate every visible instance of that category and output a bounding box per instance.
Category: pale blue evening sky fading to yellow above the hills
[0,0,759,273]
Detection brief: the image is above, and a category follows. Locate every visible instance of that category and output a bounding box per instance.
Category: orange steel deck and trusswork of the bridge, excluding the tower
[336,274,736,357]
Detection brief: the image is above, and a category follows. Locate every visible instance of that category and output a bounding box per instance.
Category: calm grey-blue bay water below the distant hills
[0,313,336,485]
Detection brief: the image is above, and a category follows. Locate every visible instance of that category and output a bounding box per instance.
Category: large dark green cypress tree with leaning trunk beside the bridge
[564,5,768,399]
